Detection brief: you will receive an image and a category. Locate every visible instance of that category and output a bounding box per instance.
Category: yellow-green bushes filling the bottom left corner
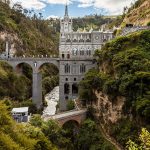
[0,102,57,150]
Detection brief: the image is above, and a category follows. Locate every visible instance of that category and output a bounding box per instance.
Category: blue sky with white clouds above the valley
[11,0,136,18]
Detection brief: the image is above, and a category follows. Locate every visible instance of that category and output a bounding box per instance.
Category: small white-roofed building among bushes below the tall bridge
[11,107,29,123]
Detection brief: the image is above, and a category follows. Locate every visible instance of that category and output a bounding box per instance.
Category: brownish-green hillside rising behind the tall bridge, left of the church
[0,1,59,55]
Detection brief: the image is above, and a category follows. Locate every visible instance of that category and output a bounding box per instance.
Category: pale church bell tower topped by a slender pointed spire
[60,4,72,34]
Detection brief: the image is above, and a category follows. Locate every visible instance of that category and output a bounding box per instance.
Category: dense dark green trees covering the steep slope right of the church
[80,31,150,146]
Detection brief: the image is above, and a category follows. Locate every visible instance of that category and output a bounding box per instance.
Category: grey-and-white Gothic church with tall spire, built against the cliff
[59,5,113,110]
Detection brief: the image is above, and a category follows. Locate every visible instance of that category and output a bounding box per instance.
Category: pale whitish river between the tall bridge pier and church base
[43,86,59,116]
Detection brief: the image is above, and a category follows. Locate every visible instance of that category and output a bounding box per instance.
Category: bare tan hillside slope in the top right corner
[123,0,150,25]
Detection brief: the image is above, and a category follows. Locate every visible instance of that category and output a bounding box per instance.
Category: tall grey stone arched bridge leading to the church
[0,57,59,108]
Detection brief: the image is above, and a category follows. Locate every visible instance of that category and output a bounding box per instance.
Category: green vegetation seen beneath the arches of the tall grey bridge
[0,61,59,113]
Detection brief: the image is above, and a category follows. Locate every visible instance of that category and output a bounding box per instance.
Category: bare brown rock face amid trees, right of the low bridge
[95,91,125,124]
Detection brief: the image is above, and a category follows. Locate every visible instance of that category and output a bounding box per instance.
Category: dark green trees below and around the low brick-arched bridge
[30,112,115,150]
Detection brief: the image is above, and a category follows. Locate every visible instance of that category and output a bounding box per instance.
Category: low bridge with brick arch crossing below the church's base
[42,109,87,126]
